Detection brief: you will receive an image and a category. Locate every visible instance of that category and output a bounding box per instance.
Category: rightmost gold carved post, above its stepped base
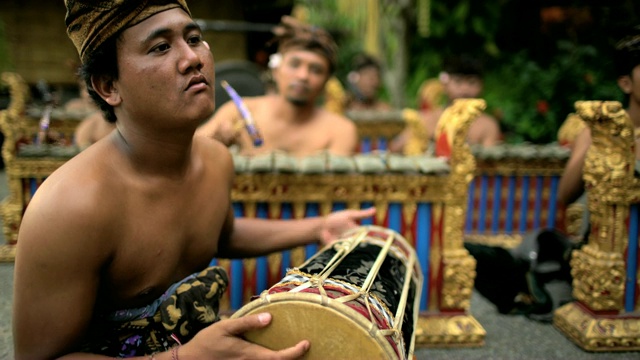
[571,101,640,311]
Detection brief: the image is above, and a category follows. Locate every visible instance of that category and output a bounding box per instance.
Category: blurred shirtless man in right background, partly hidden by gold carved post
[389,55,502,152]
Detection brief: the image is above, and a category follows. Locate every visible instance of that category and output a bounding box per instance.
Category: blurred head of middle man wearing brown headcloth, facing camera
[272,16,337,106]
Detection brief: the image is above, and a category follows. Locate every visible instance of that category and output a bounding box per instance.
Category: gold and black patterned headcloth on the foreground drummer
[64,0,191,62]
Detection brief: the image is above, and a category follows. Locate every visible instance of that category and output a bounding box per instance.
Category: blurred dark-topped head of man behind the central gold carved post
[440,55,483,101]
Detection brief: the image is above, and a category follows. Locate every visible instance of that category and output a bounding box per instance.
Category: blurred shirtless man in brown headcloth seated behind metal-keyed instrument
[197,17,358,157]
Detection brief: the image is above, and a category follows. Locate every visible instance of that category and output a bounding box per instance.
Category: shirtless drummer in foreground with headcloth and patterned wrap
[13,0,374,360]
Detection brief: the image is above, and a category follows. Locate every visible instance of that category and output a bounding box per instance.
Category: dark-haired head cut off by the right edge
[614,25,640,102]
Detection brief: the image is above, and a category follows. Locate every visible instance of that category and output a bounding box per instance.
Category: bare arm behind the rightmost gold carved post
[558,128,591,205]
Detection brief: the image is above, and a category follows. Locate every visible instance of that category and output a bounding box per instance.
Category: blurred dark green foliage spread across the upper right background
[298,0,632,143]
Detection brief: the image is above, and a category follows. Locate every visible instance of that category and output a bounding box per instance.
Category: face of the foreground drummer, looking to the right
[114,9,215,128]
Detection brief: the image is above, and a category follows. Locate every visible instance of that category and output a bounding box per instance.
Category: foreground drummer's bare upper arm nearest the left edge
[13,186,110,359]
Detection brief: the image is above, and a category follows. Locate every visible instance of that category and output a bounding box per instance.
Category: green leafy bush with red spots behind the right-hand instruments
[484,41,621,143]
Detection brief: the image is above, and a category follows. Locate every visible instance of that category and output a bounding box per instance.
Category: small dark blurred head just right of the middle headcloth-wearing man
[348,54,381,102]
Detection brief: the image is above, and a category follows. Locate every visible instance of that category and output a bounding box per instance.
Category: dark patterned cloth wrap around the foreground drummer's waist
[79,266,229,357]
